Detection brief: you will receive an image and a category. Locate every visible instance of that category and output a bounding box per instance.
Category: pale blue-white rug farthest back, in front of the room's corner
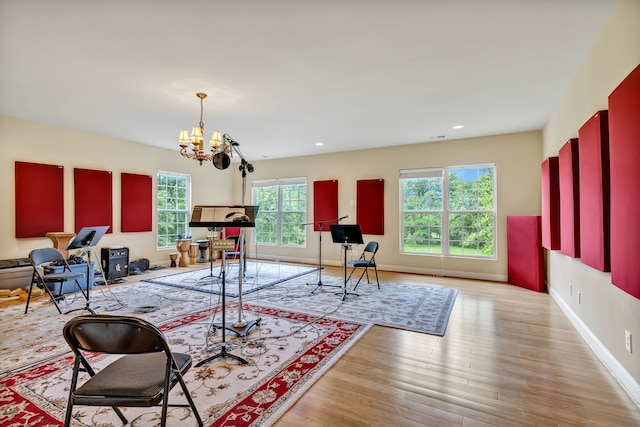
[143,261,319,298]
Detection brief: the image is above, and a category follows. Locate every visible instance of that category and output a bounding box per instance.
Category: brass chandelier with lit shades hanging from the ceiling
[178,92,233,169]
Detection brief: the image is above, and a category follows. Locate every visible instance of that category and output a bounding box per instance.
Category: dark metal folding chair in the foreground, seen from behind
[63,314,203,427]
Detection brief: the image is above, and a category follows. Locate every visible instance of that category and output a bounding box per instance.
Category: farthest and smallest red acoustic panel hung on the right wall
[542,157,560,250]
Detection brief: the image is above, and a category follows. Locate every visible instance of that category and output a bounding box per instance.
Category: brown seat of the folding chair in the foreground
[74,353,191,406]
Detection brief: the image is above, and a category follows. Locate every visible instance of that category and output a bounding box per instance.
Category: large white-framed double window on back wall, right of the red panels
[400,165,496,258]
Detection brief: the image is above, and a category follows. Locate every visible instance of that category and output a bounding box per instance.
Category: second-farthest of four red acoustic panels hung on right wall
[558,138,580,258]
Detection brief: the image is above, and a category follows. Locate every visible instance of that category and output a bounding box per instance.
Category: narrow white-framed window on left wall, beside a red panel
[157,172,191,248]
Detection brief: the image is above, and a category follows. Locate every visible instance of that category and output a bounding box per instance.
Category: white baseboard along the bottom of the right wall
[549,288,640,406]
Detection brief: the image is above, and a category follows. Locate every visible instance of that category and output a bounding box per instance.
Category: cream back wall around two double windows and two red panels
[248,132,542,281]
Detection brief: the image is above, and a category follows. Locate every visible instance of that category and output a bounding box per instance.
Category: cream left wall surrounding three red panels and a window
[0,116,240,262]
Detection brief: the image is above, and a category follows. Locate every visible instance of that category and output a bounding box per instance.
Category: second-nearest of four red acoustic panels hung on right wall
[578,111,611,271]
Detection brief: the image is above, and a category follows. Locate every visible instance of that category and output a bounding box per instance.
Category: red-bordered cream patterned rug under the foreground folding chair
[0,305,368,427]
